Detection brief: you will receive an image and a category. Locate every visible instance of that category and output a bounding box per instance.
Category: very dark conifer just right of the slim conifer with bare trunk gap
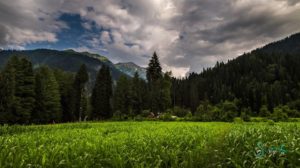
[91,65,112,120]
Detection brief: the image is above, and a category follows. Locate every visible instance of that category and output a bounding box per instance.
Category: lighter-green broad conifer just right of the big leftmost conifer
[32,67,62,123]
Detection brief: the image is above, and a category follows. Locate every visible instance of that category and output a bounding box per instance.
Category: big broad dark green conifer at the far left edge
[0,56,35,124]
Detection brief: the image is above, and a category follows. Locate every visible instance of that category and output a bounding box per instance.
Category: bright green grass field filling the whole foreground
[0,122,300,168]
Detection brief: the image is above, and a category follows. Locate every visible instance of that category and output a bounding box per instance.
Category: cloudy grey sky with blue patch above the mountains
[0,0,300,77]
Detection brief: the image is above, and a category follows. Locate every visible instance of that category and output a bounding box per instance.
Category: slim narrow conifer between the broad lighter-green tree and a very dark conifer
[73,64,89,121]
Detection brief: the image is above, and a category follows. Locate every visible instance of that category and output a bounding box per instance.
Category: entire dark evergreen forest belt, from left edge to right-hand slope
[0,34,300,124]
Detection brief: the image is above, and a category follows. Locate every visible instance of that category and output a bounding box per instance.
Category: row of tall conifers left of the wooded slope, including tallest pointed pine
[0,53,171,124]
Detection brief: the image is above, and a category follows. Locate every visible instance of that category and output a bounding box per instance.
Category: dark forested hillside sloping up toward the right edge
[172,34,300,115]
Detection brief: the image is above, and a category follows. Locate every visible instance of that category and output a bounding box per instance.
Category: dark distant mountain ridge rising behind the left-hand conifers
[0,49,145,81]
